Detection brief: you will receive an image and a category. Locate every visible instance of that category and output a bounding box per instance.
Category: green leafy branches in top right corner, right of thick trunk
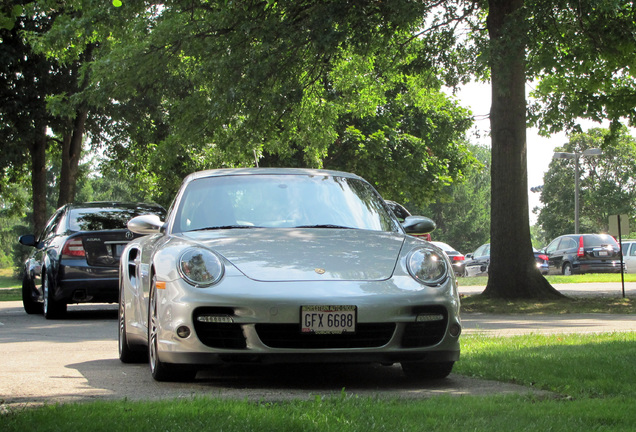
[528,0,636,133]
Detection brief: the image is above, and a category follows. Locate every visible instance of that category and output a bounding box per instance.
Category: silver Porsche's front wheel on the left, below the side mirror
[148,276,197,381]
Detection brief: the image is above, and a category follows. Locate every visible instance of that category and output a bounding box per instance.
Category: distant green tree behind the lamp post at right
[538,127,636,238]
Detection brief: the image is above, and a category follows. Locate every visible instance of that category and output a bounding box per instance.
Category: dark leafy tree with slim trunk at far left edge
[0,3,59,235]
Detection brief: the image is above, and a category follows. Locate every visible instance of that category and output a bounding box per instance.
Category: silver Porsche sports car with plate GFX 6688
[119,168,461,381]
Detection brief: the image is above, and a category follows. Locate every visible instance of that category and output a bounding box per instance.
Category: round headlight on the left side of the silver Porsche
[179,248,224,287]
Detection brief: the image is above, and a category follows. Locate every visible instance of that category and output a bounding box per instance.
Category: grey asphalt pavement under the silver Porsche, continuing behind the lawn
[0,284,636,411]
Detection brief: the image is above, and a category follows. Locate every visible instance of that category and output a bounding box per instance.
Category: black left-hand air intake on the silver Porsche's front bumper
[193,308,247,349]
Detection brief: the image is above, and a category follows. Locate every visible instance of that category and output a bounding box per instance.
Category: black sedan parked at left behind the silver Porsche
[19,202,166,318]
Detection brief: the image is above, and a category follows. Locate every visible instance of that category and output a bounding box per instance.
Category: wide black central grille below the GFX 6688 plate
[256,323,395,349]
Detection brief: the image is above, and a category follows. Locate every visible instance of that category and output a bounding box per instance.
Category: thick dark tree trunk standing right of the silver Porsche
[484,0,561,299]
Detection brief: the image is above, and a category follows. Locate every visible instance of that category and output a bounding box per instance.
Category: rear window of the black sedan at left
[69,207,165,231]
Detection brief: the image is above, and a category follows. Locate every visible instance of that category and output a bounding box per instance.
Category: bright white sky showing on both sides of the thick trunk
[455,83,580,225]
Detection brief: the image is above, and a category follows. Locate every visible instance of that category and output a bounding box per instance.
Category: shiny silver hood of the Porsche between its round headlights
[182,228,405,282]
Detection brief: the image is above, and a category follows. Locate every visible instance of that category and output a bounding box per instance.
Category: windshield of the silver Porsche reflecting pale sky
[173,174,400,232]
